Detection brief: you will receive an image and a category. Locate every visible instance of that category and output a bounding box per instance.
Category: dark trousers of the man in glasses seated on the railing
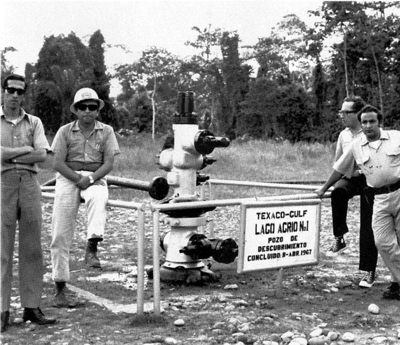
[331,175,378,271]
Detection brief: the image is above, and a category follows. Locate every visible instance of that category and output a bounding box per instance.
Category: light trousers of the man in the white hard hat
[51,171,108,282]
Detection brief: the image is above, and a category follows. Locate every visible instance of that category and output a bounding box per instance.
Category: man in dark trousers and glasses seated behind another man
[327,96,378,288]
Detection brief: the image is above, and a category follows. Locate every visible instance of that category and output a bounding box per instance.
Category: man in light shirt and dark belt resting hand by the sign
[316,105,400,300]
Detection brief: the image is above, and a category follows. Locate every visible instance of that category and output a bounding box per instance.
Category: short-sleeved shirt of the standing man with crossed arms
[0,108,50,172]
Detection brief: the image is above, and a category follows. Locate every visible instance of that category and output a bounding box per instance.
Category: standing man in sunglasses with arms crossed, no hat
[0,74,56,332]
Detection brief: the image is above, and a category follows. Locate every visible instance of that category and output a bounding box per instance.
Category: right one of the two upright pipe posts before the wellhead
[153,210,161,315]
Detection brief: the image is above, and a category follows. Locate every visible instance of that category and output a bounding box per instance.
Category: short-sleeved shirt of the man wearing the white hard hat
[51,120,120,163]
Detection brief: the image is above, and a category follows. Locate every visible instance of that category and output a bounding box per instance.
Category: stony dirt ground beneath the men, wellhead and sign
[1,198,400,345]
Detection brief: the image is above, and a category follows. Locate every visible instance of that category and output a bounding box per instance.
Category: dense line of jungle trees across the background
[1,1,400,142]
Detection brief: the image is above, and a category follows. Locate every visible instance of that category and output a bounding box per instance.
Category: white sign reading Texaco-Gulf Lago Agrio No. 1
[237,199,321,273]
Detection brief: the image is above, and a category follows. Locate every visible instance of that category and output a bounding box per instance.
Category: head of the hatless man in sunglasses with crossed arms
[1,74,27,109]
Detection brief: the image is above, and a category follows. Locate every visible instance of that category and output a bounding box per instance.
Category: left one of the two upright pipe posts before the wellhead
[137,206,145,315]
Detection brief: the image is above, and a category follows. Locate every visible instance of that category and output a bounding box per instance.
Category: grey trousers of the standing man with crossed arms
[0,169,43,311]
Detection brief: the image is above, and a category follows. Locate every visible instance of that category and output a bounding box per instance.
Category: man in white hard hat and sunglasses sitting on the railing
[51,88,120,308]
